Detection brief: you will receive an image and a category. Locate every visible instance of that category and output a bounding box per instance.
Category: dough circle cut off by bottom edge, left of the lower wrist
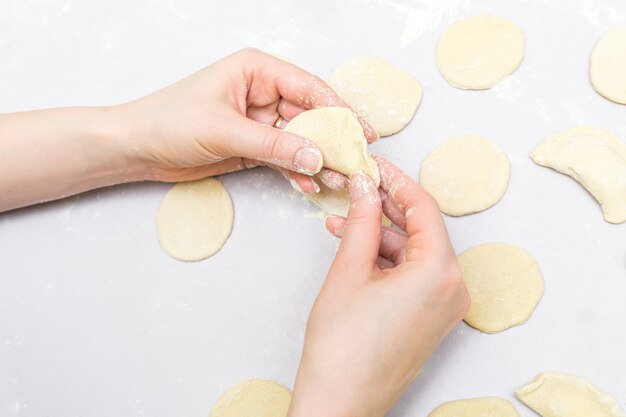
[209,379,291,417]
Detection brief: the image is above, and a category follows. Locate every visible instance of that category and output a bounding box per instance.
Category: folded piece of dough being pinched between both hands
[285,107,380,186]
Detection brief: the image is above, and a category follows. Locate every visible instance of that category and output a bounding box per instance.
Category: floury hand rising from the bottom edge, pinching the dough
[289,157,469,417]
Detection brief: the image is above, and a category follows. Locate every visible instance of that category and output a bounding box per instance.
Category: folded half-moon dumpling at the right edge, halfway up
[530,127,626,223]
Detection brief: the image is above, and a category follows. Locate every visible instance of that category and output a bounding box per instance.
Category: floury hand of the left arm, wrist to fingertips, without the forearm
[120,49,377,193]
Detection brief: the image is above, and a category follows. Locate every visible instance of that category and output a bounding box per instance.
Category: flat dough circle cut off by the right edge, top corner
[589,25,626,104]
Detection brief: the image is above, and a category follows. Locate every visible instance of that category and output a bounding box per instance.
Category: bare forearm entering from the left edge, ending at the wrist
[0,107,143,212]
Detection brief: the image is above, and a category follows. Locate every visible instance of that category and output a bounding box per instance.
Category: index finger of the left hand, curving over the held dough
[243,51,379,143]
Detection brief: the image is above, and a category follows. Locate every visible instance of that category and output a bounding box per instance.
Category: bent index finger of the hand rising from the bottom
[373,155,451,260]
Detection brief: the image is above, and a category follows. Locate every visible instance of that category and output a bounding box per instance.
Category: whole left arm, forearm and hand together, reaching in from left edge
[0,49,370,212]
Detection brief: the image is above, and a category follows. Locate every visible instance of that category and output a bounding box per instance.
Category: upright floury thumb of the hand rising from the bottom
[336,174,382,268]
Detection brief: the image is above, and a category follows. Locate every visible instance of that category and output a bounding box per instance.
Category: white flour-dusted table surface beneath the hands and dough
[0,0,626,417]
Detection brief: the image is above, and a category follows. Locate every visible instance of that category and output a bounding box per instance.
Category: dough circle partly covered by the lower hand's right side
[458,243,543,333]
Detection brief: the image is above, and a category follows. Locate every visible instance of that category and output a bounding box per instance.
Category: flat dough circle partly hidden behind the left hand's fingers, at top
[328,56,422,136]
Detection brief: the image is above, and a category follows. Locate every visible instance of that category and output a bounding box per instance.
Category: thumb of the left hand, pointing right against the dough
[225,116,324,175]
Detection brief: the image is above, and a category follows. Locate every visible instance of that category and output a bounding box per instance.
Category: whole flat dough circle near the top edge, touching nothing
[437,16,524,90]
